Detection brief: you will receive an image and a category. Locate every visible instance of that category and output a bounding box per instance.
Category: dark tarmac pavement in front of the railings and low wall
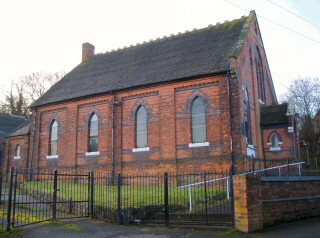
[8,217,320,238]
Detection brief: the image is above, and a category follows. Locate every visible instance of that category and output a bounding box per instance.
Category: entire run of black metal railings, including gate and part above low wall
[0,158,319,229]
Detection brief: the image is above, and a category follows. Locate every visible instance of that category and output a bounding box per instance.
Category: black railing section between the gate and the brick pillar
[92,171,232,225]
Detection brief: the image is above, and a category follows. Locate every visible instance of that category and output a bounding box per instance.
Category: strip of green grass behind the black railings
[23,181,227,207]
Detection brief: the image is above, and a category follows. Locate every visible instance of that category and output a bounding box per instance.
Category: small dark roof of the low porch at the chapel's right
[261,103,288,126]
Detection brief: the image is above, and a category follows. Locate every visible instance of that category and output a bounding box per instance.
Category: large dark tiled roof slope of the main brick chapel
[32,11,255,107]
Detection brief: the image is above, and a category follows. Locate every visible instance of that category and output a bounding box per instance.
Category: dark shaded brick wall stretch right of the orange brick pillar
[261,177,320,226]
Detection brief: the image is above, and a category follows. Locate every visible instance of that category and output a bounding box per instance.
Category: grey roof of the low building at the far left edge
[0,113,27,139]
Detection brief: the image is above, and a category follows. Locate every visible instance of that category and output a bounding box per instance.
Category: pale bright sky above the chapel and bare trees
[0,0,320,99]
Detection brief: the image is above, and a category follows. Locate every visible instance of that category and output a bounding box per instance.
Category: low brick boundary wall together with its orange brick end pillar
[234,175,320,232]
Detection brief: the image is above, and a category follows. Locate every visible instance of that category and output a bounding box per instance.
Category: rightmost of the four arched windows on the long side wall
[191,97,207,143]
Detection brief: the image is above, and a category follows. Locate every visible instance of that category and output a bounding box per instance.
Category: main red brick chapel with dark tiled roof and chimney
[3,11,300,173]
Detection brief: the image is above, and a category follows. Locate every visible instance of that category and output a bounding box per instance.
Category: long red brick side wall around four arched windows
[29,74,238,173]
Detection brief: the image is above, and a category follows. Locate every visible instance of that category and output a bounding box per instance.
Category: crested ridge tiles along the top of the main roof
[98,12,251,56]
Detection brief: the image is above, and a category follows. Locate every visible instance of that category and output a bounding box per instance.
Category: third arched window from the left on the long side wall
[136,106,148,148]
